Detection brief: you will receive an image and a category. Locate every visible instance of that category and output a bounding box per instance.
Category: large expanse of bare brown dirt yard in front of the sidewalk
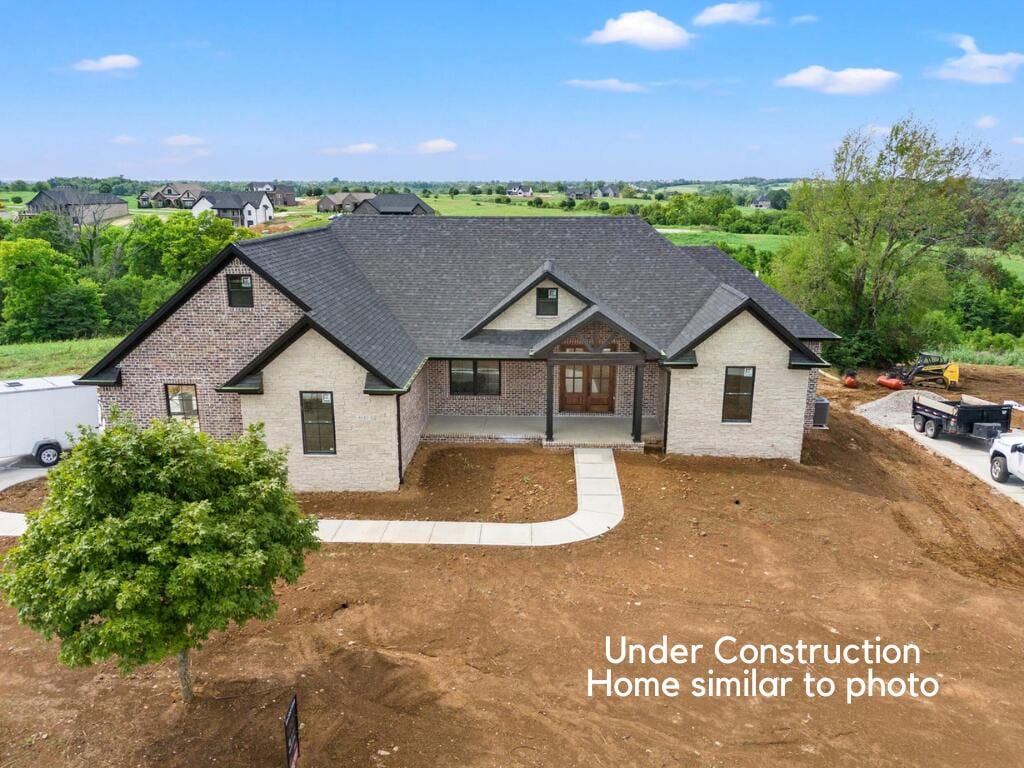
[0,370,1024,768]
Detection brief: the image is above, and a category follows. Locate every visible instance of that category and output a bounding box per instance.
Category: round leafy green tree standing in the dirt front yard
[0,417,317,701]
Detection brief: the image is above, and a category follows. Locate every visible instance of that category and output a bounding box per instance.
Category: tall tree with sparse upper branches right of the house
[775,119,989,362]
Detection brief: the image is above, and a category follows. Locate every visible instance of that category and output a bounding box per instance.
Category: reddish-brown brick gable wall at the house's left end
[98,259,302,437]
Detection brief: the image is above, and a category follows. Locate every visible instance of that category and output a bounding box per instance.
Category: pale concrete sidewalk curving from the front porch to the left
[0,449,623,547]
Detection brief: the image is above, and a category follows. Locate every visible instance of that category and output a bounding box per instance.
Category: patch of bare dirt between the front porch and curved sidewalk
[299,444,577,522]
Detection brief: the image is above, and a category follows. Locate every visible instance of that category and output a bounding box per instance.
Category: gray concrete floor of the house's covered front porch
[421,416,663,451]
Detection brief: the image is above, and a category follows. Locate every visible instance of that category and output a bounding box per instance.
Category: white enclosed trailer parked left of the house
[0,376,99,467]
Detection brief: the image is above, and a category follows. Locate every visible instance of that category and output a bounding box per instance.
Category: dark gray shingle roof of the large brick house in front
[234,217,835,387]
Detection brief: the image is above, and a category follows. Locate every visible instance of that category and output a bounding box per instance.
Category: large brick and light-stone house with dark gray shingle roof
[79,216,837,490]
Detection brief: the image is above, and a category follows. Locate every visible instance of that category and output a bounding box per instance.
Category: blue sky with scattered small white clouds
[0,0,1024,180]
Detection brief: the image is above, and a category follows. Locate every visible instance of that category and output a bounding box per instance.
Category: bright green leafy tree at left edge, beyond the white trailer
[0,240,104,342]
